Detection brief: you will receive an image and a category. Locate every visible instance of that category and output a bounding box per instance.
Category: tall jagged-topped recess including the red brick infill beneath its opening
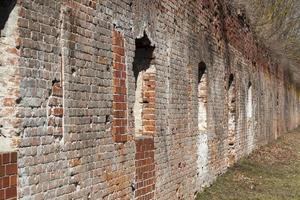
[133,33,155,199]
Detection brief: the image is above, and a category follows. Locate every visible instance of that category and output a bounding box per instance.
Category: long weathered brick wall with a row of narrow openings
[0,0,300,199]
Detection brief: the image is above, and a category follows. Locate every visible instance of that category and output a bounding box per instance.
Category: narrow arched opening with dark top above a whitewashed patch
[198,62,207,131]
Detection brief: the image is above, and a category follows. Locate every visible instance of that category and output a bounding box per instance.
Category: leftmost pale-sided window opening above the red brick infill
[0,0,22,154]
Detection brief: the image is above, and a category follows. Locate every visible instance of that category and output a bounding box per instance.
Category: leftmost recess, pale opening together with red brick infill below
[0,0,18,199]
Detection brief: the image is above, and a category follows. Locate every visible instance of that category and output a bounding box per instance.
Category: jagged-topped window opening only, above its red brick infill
[133,34,155,135]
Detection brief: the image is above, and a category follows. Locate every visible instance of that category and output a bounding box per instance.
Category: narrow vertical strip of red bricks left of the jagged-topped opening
[112,30,128,142]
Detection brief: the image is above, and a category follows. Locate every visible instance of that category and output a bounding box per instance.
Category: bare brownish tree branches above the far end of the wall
[233,0,300,81]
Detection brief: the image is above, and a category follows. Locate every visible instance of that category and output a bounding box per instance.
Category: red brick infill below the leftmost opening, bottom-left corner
[0,152,18,200]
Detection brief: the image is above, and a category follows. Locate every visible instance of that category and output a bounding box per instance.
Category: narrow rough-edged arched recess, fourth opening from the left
[227,74,237,166]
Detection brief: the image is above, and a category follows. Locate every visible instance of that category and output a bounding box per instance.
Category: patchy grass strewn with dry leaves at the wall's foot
[196,128,300,200]
